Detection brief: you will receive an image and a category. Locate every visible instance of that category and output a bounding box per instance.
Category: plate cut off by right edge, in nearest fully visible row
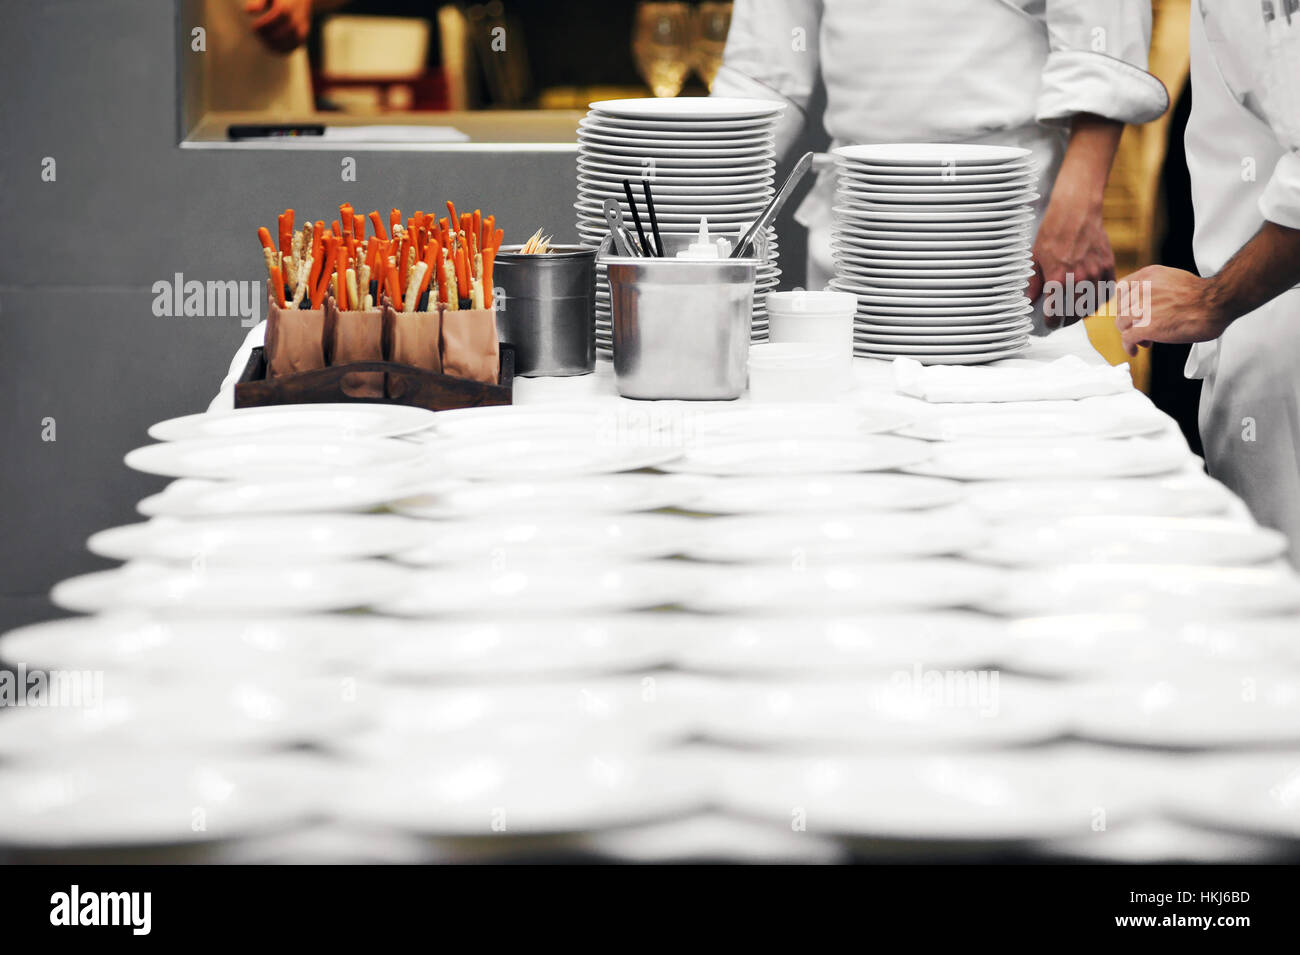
[1171,751,1300,839]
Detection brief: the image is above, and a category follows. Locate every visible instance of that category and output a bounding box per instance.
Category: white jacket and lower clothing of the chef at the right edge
[1186,0,1300,565]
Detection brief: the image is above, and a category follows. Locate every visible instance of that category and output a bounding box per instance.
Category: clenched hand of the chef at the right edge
[1115,265,1230,355]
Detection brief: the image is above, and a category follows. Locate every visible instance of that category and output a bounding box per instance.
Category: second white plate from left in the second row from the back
[438,434,681,481]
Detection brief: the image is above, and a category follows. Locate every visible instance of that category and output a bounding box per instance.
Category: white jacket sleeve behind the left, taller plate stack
[712,0,822,155]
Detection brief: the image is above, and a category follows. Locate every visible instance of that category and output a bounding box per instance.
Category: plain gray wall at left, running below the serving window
[0,0,803,629]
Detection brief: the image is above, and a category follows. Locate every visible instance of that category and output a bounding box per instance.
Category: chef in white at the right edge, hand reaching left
[1115,0,1300,567]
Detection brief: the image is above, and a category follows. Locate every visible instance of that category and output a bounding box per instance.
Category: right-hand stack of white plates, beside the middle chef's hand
[831,143,1037,365]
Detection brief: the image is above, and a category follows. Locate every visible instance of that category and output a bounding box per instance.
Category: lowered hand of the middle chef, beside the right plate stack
[1024,184,1115,329]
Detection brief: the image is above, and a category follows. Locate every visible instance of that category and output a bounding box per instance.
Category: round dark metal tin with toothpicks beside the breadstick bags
[493,246,597,377]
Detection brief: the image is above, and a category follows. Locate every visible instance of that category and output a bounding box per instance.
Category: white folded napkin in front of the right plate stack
[893,355,1132,401]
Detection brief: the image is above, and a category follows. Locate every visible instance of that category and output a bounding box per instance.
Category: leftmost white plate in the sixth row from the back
[0,613,400,680]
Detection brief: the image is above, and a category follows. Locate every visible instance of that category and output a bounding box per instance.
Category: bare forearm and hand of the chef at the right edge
[1115,222,1300,355]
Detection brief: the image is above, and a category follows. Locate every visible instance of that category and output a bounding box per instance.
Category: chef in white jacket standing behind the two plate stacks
[712,0,1169,327]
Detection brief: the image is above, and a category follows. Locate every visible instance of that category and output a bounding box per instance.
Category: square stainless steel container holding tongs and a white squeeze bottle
[602,257,758,401]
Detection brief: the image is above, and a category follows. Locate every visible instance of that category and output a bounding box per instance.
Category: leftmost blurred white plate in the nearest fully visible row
[0,751,316,851]
